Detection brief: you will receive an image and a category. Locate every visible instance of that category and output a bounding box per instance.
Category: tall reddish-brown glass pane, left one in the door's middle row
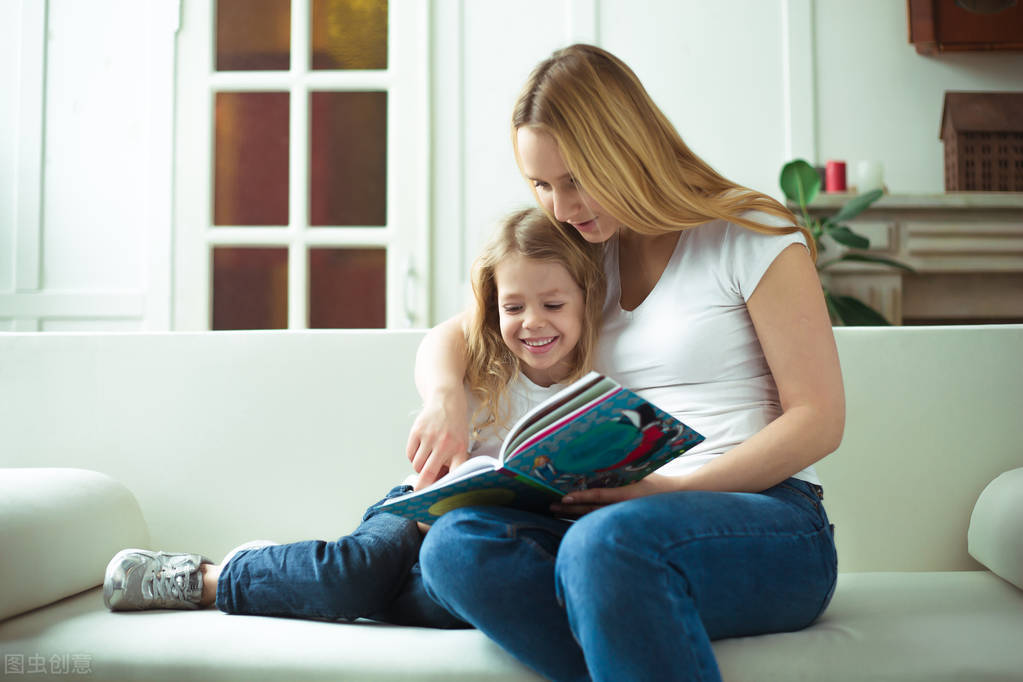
[213,92,288,225]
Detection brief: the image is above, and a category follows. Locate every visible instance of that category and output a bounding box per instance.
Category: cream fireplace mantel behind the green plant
[802,192,1023,324]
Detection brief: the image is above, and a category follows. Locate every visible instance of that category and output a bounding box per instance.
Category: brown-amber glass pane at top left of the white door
[217,0,292,71]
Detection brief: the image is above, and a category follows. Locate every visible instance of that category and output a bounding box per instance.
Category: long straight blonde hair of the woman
[512,44,816,257]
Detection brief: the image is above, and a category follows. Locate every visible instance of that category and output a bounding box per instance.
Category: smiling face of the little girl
[494,256,584,387]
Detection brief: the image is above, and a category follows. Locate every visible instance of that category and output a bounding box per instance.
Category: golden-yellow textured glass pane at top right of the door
[310,0,388,70]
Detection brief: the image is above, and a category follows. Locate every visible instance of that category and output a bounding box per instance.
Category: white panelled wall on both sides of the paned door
[0,0,1023,330]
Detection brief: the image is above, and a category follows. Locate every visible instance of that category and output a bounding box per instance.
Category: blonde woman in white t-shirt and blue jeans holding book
[407,45,845,680]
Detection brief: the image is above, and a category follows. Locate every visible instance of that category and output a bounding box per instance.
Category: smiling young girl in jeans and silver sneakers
[103,209,605,628]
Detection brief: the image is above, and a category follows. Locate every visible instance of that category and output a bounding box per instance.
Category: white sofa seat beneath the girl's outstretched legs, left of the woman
[0,589,541,682]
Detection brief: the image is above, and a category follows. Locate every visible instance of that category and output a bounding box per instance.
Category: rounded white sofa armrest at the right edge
[967,467,1023,589]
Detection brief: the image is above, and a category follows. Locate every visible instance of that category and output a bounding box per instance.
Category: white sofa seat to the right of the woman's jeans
[714,571,1023,682]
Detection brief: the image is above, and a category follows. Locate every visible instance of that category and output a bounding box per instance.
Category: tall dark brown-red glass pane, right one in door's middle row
[309,92,387,226]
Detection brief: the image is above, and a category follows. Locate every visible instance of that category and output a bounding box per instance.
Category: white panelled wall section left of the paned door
[0,0,177,330]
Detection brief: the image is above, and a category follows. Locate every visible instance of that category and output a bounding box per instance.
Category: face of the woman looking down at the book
[516,127,622,243]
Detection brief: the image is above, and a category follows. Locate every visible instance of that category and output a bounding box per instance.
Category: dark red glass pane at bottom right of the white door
[309,248,387,329]
